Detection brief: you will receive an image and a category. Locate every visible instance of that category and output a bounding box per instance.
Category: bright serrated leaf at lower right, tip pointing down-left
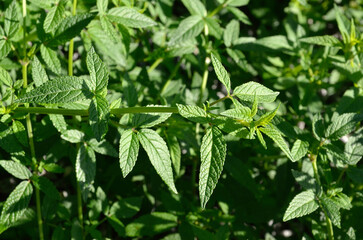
[283,190,319,222]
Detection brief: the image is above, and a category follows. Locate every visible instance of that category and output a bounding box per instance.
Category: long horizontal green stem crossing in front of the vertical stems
[13,107,178,116]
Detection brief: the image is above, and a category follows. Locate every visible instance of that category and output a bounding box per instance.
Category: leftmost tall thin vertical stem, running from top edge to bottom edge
[21,0,44,240]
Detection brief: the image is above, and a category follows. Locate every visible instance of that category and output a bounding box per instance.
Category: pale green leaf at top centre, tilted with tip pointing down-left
[169,15,204,45]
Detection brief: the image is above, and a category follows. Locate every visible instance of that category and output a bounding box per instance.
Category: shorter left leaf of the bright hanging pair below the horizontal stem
[119,129,139,178]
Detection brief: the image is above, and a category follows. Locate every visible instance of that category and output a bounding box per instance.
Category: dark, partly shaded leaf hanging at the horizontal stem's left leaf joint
[88,96,110,141]
